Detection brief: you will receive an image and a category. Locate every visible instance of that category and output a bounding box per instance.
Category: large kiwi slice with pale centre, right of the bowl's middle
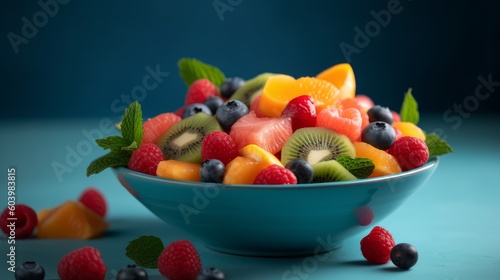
[281,127,356,165]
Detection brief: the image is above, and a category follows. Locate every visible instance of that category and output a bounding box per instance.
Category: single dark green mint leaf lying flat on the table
[125,235,164,268]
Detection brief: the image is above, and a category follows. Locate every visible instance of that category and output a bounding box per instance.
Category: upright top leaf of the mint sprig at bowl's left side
[121,100,144,143]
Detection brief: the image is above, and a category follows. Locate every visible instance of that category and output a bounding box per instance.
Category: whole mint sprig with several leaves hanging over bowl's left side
[87,101,144,176]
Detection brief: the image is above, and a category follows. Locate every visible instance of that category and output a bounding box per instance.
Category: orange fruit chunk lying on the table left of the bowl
[36,200,108,239]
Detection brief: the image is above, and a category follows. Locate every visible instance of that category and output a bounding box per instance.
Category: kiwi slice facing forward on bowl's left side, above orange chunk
[157,113,222,163]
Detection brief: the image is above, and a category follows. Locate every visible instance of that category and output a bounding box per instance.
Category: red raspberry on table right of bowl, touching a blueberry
[360,226,395,264]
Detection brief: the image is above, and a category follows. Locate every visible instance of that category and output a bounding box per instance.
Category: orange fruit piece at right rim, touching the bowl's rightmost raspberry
[353,142,402,178]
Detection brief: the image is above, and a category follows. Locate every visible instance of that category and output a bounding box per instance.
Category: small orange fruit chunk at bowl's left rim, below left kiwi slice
[156,159,201,182]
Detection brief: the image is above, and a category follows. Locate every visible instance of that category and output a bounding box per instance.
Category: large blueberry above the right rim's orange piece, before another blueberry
[361,121,396,150]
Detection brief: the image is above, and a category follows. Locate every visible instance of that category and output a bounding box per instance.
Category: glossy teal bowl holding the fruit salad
[113,158,439,256]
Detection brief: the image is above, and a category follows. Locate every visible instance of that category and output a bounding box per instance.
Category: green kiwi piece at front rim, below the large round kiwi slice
[313,160,357,183]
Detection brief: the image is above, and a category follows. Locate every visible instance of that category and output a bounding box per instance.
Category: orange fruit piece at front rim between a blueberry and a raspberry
[222,156,269,185]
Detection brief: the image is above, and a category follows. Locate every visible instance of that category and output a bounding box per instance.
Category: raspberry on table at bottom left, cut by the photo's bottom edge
[57,247,107,280]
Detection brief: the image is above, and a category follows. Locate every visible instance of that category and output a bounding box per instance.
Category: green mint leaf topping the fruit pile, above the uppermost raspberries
[177,58,226,87]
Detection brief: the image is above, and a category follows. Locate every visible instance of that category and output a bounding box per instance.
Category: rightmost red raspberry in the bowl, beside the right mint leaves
[387,136,429,171]
